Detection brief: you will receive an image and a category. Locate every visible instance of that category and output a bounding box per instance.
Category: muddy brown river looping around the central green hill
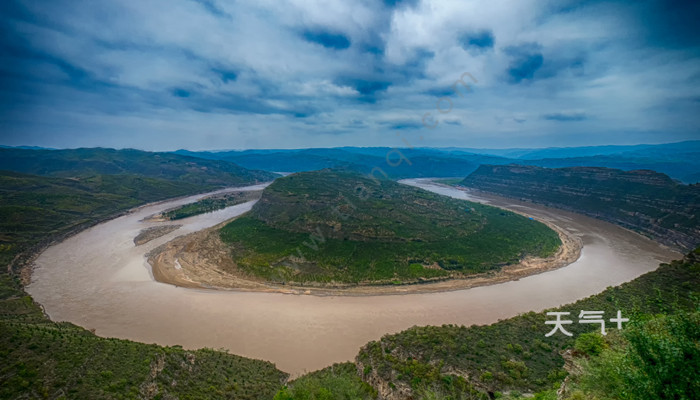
[27,179,681,376]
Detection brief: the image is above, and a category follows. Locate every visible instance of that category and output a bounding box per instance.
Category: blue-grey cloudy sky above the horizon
[0,0,700,150]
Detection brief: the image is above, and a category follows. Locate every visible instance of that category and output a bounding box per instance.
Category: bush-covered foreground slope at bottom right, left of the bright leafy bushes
[356,249,700,398]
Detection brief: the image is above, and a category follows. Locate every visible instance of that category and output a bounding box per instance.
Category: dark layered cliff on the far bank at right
[461,165,700,250]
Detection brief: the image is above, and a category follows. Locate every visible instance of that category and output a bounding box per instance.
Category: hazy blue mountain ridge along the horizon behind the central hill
[176,141,700,183]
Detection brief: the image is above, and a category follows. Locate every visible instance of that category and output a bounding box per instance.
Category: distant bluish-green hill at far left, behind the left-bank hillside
[0,148,278,187]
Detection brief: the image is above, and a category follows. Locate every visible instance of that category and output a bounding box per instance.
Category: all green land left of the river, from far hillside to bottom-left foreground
[0,172,287,399]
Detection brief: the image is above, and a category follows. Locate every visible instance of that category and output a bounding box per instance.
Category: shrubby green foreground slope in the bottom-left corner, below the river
[0,273,286,399]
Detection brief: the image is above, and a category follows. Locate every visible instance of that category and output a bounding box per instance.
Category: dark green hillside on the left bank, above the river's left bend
[0,172,209,255]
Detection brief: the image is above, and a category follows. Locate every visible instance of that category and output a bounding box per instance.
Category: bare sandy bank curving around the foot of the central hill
[148,206,582,296]
